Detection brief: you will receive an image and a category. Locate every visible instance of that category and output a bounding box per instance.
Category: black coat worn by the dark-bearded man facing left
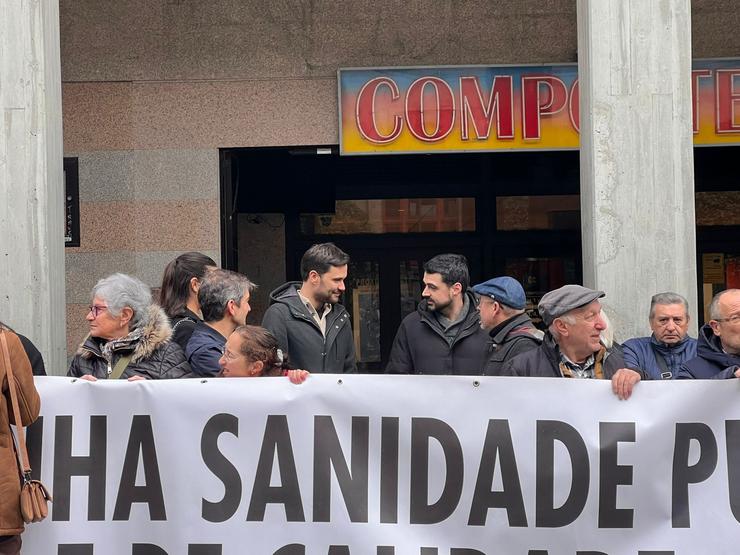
[385,291,489,376]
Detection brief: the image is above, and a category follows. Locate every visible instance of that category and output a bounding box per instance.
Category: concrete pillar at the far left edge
[0,0,66,374]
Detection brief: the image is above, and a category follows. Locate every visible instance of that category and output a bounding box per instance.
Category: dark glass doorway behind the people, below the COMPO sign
[221,146,582,372]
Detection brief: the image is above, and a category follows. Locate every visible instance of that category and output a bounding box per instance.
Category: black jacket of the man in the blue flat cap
[483,313,544,376]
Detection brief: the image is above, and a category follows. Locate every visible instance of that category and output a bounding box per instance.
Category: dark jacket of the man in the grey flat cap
[501,333,645,380]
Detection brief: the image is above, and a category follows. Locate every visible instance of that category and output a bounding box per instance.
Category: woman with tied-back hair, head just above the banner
[218,325,309,384]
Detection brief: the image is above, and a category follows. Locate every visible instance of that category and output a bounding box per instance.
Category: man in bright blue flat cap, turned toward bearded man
[473,276,544,376]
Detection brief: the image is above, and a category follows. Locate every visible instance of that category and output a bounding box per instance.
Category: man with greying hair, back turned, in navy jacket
[185,268,255,376]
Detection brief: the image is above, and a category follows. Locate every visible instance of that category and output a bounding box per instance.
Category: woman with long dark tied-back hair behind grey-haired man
[159,252,216,351]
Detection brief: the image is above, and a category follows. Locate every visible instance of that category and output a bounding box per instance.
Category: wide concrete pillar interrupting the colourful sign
[577,0,698,340]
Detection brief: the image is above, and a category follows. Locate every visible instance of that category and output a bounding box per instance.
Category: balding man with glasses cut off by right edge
[678,289,740,379]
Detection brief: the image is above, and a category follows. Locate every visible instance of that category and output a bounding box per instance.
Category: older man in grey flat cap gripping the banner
[502,285,642,399]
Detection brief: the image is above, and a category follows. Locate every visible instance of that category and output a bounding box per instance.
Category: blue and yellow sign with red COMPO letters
[338,60,740,154]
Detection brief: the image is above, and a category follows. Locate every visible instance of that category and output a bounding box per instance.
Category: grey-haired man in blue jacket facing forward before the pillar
[623,292,696,380]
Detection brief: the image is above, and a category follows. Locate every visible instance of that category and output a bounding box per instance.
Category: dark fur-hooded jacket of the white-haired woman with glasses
[67,305,192,380]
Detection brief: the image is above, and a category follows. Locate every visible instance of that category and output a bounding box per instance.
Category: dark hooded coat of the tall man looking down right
[262,281,357,374]
